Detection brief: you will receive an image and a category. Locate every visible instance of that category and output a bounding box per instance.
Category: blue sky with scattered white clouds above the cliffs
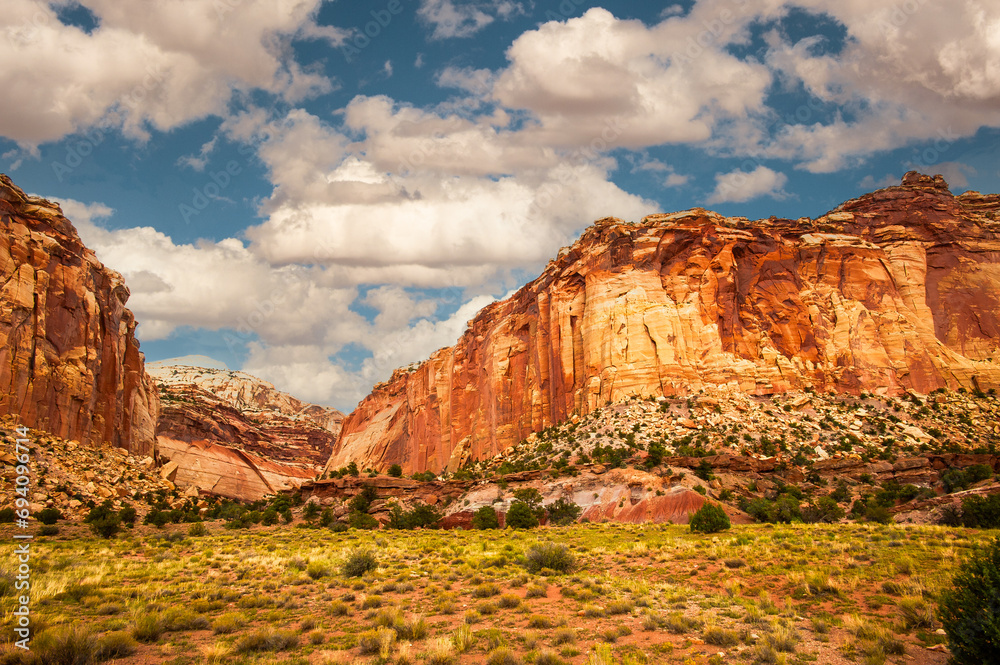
[0,0,1000,410]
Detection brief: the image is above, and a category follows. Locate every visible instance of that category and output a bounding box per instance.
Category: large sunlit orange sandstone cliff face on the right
[328,173,1000,472]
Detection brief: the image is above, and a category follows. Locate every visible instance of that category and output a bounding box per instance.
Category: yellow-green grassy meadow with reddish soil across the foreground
[0,522,988,665]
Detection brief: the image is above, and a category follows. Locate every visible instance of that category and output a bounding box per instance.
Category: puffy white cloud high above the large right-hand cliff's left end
[493,8,771,148]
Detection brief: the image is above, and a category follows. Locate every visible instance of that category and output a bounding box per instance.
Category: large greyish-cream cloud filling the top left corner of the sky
[0,0,344,149]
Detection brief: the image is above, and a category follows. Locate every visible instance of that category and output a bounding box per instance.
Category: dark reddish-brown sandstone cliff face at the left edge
[0,174,159,455]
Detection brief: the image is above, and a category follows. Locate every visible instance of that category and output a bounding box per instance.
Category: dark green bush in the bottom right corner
[937,538,1000,665]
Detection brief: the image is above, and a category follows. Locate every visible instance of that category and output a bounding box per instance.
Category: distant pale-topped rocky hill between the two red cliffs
[149,363,344,500]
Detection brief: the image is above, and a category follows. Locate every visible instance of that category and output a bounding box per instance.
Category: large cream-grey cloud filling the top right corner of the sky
[750,0,1000,173]
